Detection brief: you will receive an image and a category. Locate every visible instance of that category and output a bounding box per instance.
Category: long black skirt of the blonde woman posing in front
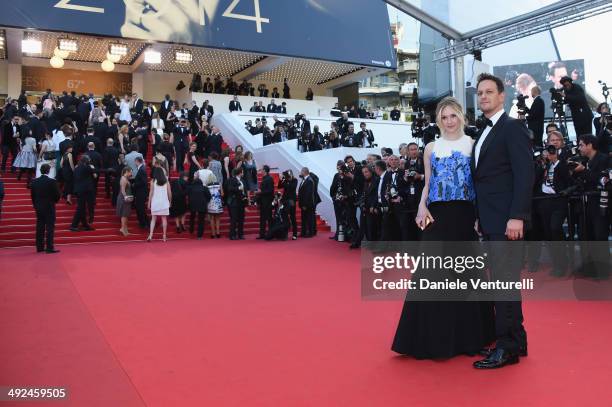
[391,201,495,359]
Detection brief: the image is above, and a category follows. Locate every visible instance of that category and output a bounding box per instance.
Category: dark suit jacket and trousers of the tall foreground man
[471,113,534,354]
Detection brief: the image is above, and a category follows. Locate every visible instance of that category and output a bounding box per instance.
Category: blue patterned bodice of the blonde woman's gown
[427,151,476,204]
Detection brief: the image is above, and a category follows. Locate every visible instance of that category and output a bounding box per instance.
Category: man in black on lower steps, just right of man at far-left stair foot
[70,154,98,232]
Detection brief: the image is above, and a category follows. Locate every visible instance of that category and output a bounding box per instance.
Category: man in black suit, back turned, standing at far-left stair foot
[31,164,60,253]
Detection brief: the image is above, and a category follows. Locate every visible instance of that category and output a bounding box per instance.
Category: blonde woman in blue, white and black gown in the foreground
[392,98,495,359]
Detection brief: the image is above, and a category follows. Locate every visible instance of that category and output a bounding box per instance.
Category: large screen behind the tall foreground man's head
[493,59,585,117]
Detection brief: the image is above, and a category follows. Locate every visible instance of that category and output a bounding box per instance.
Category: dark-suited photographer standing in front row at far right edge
[572,134,610,241]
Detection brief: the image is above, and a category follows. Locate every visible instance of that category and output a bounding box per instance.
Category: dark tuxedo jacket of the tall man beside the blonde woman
[471,113,534,235]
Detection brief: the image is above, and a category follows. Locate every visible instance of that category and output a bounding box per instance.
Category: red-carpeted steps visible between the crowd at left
[0,155,329,248]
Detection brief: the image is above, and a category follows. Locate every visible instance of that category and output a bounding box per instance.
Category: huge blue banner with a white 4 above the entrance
[0,0,396,69]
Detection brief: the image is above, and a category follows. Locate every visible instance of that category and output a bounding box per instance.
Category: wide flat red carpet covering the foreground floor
[0,236,612,407]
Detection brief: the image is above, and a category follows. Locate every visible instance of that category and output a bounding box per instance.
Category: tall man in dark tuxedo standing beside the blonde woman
[471,73,534,369]
